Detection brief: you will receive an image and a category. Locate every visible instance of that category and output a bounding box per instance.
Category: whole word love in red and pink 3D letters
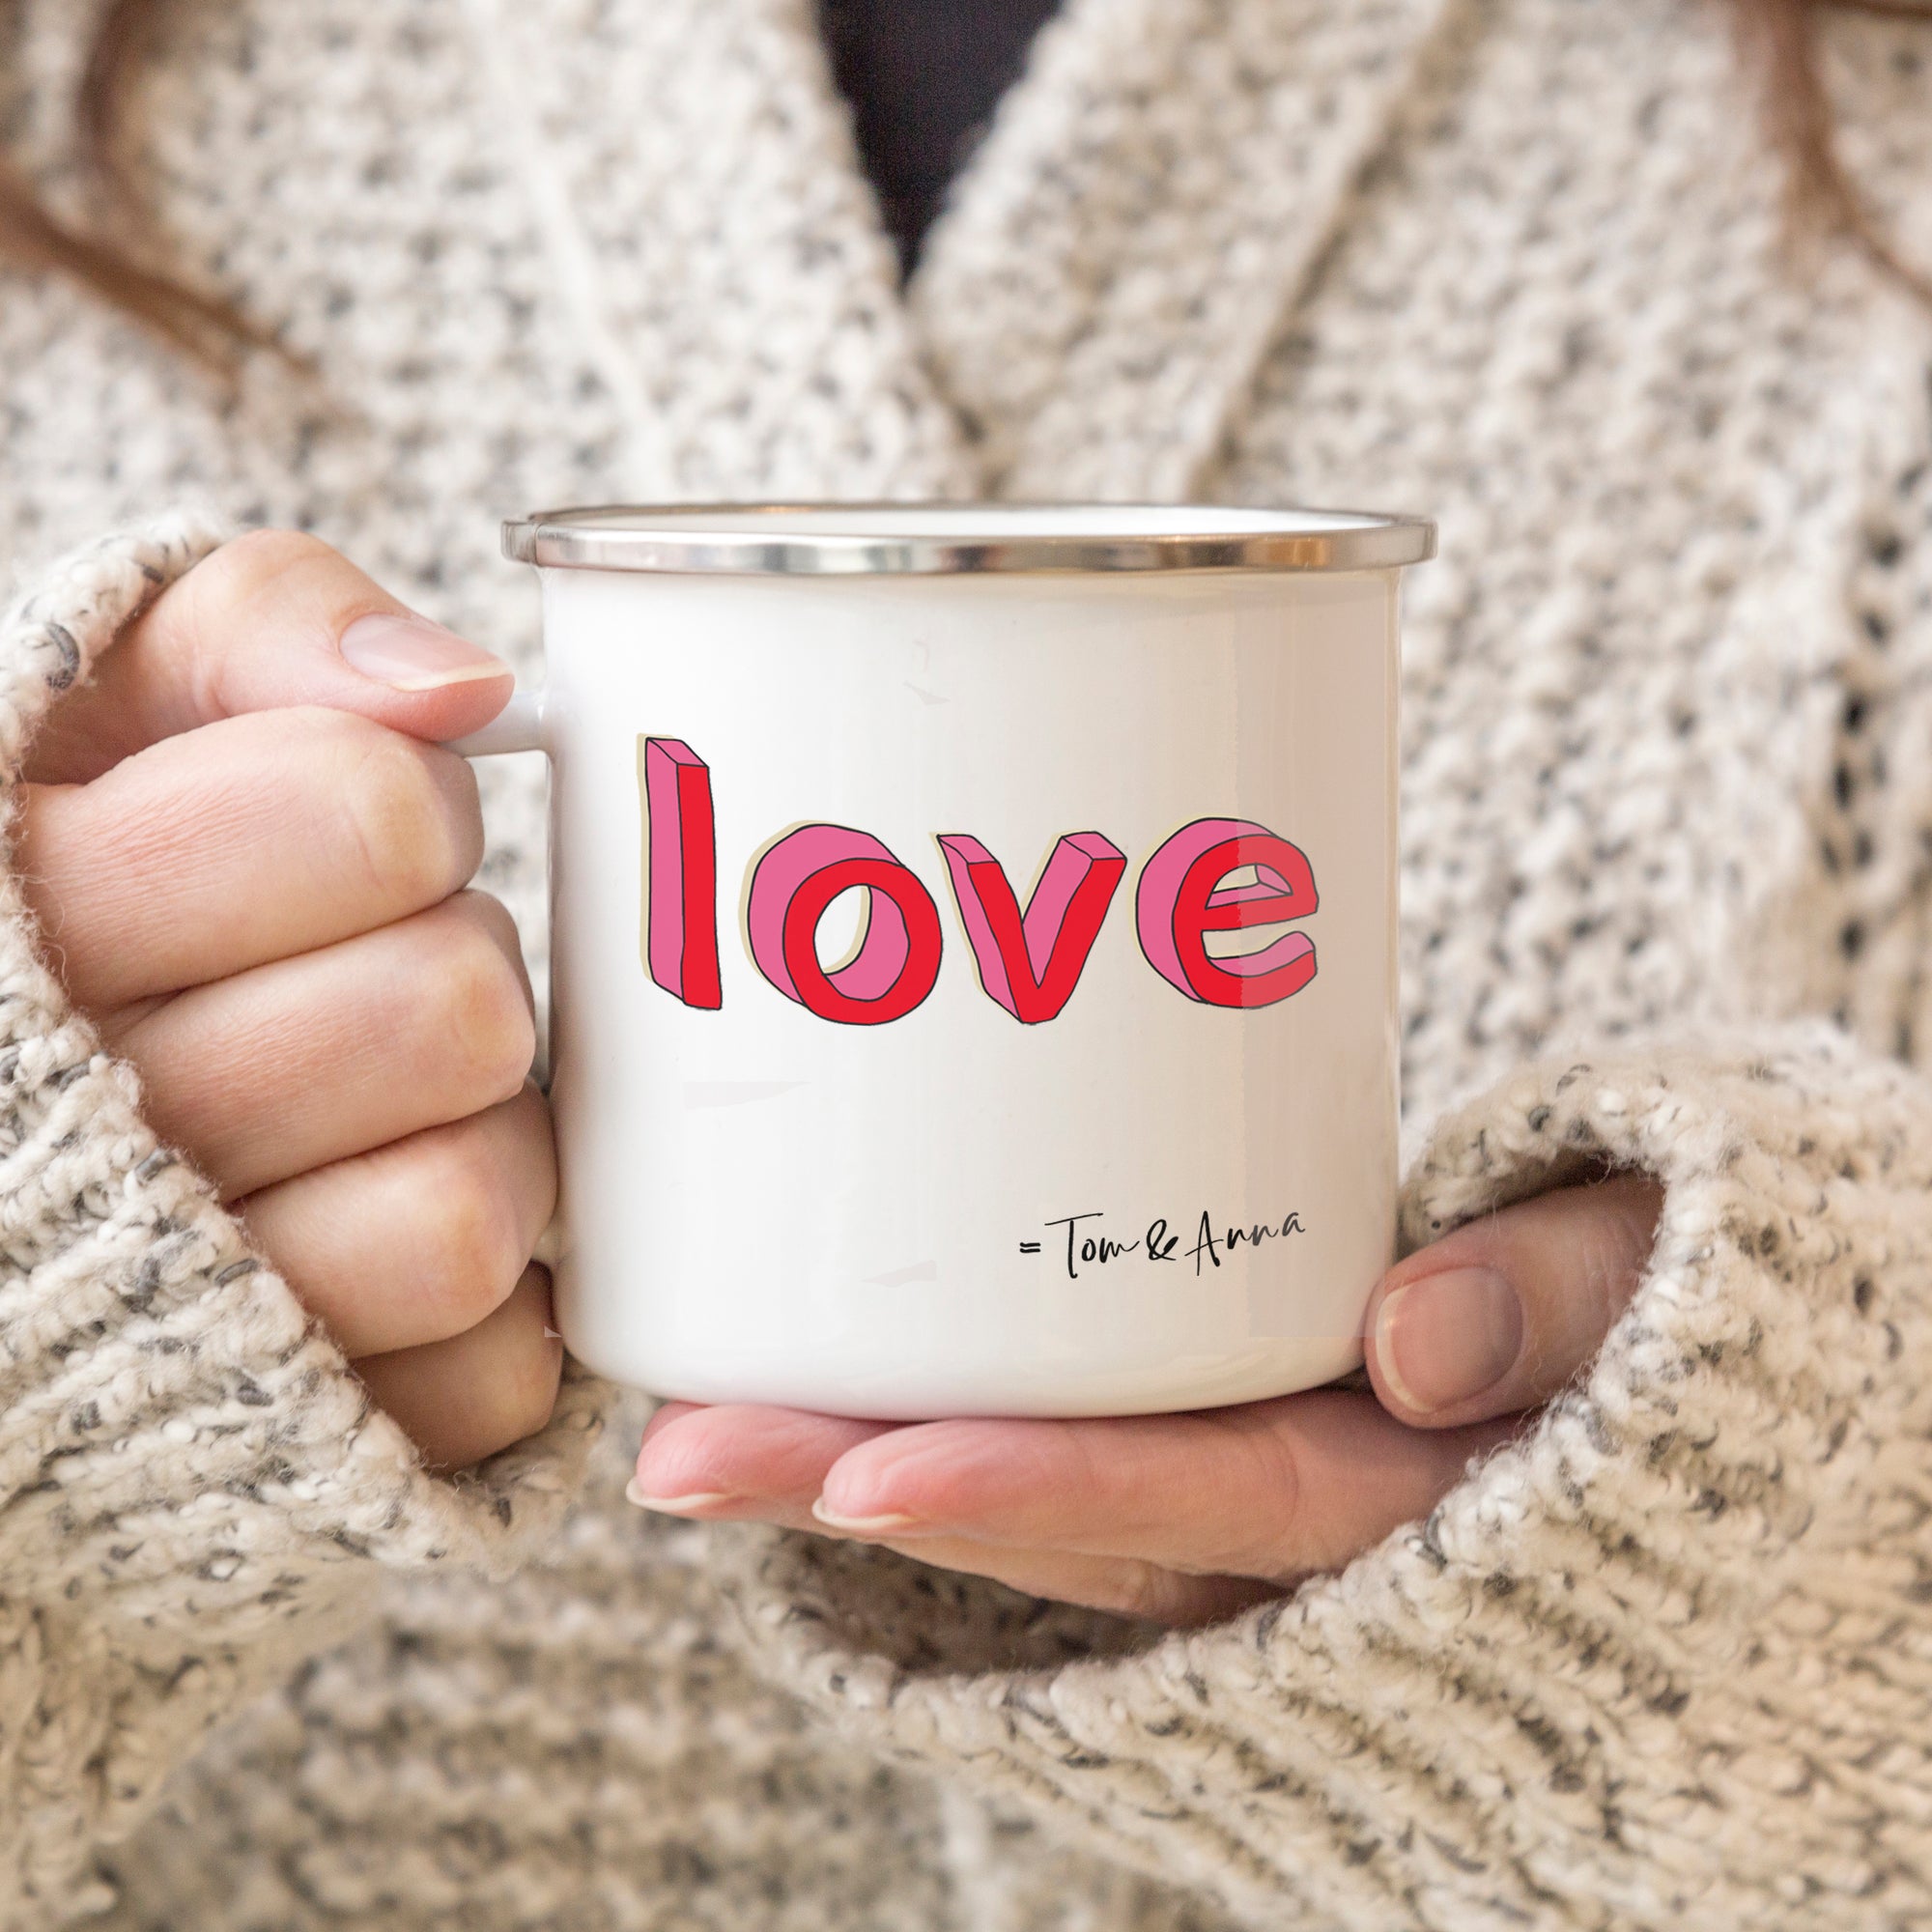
[638,736,1320,1026]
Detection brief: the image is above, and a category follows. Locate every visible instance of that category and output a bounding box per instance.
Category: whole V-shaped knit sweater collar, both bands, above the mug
[468,0,1461,498]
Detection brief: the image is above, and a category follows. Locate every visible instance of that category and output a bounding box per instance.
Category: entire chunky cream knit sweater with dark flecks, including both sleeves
[0,0,1932,1932]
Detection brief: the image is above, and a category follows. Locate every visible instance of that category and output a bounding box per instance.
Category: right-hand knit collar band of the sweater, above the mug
[910,0,1461,500]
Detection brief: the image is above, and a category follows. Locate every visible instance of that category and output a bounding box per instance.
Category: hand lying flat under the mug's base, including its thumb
[632,1175,1660,1623]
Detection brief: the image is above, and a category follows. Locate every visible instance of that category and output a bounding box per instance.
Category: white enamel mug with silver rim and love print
[460,504,1434,1420]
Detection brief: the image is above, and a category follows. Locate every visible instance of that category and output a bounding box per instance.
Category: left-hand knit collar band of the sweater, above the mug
[464,0,978,502]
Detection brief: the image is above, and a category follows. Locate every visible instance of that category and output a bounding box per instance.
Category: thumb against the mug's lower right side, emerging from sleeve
[1366,1175,1663,1428]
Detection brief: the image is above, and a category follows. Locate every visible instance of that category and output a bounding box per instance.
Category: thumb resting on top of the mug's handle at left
[27,529,516,784]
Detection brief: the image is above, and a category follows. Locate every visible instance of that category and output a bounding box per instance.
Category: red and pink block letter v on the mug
[939,833,1126,1026]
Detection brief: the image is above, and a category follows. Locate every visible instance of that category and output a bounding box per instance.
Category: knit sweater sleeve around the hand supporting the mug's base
[715,1026,1932,1928]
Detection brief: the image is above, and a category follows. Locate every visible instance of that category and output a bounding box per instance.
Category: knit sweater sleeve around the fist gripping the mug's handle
[0,516,597,1924]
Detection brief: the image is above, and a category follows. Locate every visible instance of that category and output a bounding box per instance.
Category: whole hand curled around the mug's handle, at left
[14,531,562,1466]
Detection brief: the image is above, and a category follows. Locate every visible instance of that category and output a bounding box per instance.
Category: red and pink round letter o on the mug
[746,825,943,1026]
